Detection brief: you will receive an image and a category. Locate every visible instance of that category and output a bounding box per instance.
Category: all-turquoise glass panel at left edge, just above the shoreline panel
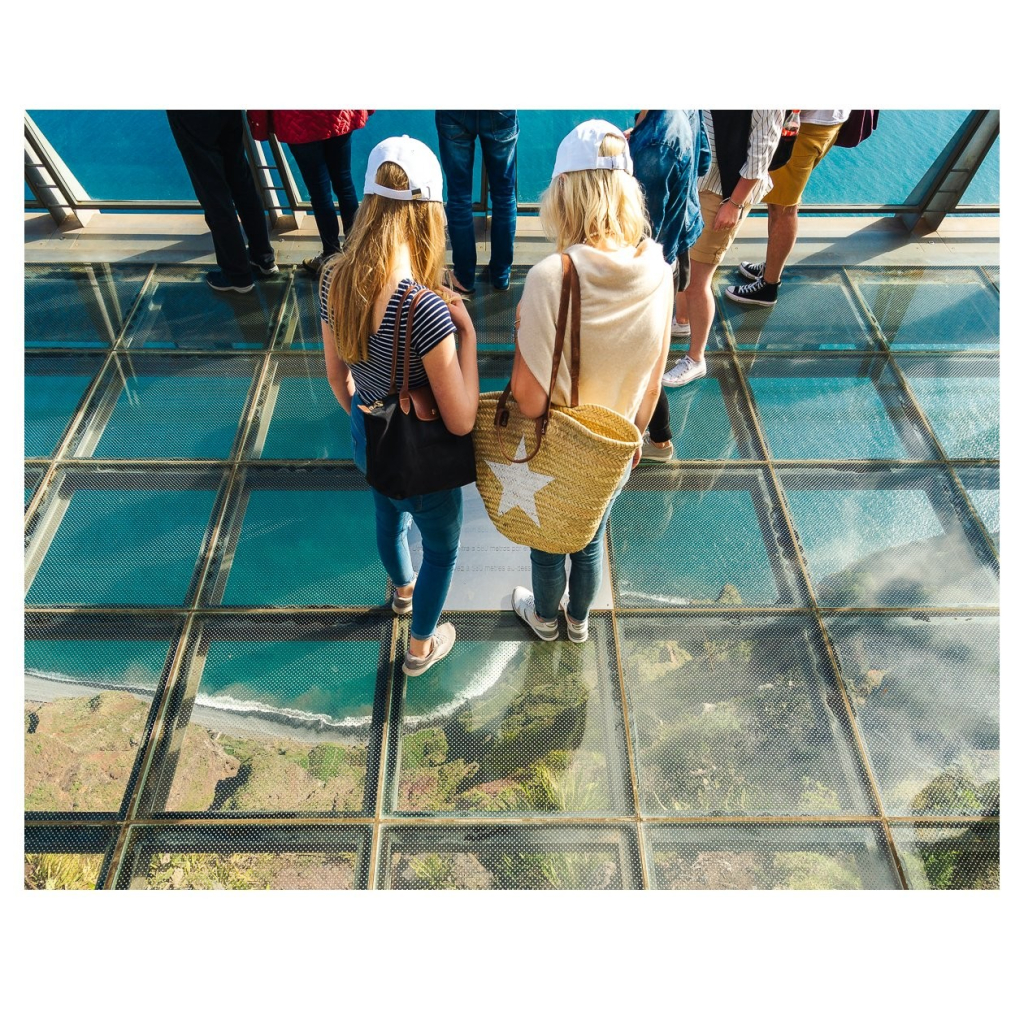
[26,470,222,605]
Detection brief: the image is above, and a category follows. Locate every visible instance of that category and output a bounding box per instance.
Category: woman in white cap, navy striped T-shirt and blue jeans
[321,135,479,676]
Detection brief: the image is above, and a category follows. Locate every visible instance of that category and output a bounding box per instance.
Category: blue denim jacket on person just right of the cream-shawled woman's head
[630,111,711,264]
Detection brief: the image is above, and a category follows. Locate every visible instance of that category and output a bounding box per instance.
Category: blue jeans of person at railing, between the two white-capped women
[434,111,519,288]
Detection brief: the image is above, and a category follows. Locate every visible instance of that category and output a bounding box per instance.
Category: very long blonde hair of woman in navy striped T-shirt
[321,161,444,362]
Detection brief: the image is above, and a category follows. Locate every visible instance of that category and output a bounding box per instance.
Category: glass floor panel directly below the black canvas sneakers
[714,267,878,351]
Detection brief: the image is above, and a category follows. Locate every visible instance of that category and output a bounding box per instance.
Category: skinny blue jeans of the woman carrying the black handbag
[351,394,462,640]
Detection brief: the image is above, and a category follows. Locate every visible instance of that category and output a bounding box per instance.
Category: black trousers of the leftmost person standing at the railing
[167,111,273,285]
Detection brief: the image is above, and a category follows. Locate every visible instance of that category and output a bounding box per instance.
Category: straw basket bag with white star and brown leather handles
[473,253,641,555]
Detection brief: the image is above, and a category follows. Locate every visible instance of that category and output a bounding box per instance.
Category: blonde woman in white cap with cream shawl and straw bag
[512,121,674,643]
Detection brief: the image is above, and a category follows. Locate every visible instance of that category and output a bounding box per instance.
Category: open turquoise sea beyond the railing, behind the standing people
[27,110,999,204]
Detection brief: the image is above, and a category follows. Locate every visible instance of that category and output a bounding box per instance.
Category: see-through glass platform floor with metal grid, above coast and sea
[25,264,999,889]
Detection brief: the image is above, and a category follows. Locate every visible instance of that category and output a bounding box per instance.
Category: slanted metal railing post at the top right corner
[899,111,999,234]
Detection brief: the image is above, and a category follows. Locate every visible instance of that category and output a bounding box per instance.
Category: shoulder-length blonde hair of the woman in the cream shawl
[541,134,650,252]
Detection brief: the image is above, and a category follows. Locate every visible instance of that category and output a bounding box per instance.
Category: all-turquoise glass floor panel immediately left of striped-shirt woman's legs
[214,468,387,607]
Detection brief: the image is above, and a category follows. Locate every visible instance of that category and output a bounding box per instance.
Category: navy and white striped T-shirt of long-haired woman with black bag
[319,271,455,402]
